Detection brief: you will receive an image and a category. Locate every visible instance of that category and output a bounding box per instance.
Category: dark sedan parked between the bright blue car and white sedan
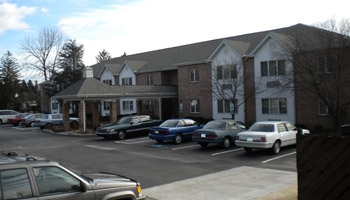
[192,120,248,148]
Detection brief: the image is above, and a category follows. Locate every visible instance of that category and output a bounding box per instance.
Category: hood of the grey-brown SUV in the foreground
[84,173,137,190]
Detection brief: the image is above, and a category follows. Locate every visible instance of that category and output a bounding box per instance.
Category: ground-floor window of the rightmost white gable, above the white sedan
[261,98,287,114]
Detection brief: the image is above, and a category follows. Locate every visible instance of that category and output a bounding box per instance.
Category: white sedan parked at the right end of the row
[235,121,310,154]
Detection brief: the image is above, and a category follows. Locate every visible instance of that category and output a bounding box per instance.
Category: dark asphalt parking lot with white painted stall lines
[0,125,296,199]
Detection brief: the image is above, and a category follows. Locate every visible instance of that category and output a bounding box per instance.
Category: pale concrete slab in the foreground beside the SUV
[143,166,298,200]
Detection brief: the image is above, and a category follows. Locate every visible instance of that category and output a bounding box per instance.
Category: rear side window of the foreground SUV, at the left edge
[0,169,33,199]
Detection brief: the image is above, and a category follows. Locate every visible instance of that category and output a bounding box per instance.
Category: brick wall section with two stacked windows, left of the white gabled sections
[178,64,213,119]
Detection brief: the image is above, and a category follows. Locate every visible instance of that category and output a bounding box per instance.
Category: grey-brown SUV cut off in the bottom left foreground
[0,153,146,200]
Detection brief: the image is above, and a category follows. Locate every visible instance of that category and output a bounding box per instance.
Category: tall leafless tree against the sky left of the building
[21,27,65,81]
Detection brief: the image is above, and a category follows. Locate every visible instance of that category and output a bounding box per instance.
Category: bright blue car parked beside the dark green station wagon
[148,119,204,144]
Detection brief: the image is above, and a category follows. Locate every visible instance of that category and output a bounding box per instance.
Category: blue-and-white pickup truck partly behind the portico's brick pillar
[33,114,79,129]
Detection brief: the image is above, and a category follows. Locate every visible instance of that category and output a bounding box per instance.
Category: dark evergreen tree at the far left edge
[0,51,20,110]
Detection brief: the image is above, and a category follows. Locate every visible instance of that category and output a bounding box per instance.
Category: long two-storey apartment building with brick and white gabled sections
[55,24,350,132]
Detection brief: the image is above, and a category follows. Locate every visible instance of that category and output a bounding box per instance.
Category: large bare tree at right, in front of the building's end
[293,19,350,133]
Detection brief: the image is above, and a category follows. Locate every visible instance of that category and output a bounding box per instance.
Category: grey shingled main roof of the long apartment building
[91,24,344,73]
